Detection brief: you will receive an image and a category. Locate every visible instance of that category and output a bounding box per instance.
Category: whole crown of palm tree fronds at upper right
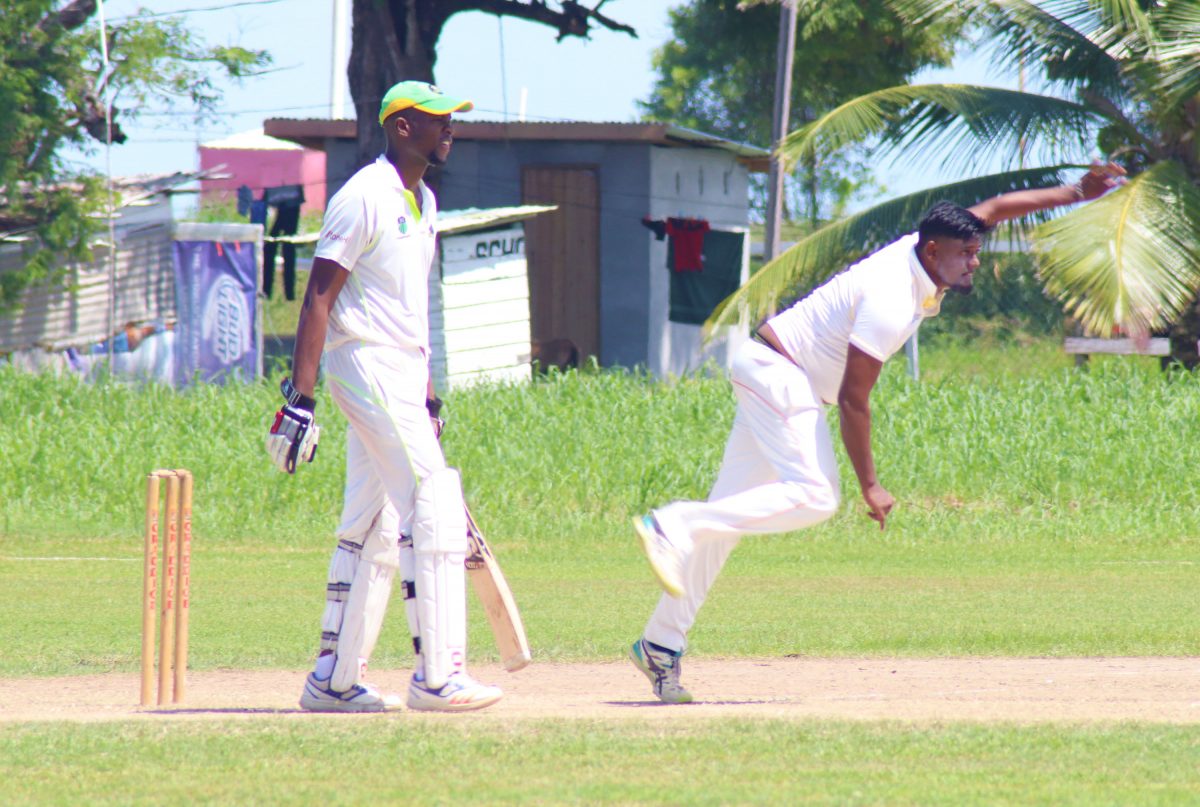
[725,0,1200,345]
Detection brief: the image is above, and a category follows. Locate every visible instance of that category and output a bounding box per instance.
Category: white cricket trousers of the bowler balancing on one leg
[643,340,839,652]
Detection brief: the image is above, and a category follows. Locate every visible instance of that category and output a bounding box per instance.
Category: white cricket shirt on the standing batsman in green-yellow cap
[316,155,438,354]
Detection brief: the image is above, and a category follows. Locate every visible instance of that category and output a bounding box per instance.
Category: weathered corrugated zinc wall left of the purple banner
[0,220,175,353]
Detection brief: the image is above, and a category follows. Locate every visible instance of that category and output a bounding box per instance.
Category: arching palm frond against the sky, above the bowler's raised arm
[780,84,1112,173]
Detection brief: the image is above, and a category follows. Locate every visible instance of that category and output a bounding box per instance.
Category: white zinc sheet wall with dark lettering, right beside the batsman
[430,225,530,389]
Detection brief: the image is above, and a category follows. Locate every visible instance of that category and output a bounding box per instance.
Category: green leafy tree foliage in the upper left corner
[0,0,270,305]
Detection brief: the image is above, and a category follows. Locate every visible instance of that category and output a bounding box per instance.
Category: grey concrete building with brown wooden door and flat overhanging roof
[264,119,768,375]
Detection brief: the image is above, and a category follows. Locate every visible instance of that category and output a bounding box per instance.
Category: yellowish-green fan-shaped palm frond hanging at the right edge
[1033,162,1200,335]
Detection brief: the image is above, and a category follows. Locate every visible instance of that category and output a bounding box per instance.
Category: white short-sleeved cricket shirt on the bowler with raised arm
[768,233,942,404]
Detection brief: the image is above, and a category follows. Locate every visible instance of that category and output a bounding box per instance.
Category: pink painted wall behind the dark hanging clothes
[199,145,325,213]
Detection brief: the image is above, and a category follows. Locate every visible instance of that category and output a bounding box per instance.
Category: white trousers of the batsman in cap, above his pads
[324,343,446,543]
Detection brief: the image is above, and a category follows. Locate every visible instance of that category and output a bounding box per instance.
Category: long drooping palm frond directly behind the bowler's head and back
[704,165,1080,339]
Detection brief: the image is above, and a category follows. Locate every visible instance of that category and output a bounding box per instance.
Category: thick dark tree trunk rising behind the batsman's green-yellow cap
[348,0,449,166]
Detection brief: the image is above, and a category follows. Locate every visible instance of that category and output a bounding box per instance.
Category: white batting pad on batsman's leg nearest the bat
[413,468,468,689]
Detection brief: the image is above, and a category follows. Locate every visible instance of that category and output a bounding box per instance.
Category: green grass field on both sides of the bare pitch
[0,337,1200,803]
